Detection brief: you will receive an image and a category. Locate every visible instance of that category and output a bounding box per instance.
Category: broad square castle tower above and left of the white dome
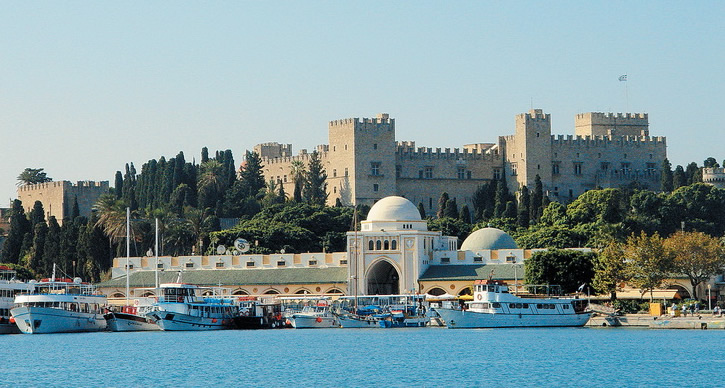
[325,113,396,205]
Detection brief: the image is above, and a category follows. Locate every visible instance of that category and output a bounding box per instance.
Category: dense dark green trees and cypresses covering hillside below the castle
[2,152,725,292]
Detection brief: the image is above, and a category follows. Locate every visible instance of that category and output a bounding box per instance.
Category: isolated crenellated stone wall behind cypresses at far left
[18,181,109,225]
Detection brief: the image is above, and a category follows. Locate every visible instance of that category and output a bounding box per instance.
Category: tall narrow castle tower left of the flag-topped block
[503,109,552,192]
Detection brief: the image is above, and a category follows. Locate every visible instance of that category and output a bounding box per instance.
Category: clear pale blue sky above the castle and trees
[0,1,725,206]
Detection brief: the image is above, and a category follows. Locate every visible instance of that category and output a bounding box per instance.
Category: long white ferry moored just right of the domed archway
[434,280,591,329]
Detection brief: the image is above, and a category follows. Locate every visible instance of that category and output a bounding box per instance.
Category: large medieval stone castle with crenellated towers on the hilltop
[254,109,667,215]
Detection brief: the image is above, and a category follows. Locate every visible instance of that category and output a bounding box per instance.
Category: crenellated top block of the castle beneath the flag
[574,112,649,136]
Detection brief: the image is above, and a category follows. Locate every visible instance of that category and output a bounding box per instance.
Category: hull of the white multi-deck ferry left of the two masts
[10,307,106,334]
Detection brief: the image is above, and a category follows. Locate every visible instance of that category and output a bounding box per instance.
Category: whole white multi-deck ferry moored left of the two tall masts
[10,277,106,334]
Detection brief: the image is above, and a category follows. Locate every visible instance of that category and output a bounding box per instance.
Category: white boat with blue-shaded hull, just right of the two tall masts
[147,283,239,330]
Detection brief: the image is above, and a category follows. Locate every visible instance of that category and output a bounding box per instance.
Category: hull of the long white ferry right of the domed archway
[435,308,591,329]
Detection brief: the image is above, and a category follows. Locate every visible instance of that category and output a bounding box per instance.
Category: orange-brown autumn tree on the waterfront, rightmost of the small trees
[664,232,725,300]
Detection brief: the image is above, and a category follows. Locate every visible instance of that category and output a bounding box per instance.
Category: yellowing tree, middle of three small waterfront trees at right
[623,232,673,300]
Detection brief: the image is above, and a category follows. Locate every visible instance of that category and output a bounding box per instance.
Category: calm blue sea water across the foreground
[0,328,725,387]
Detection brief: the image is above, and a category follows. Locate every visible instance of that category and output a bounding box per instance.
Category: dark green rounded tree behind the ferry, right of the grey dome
[524,249,594,293]
